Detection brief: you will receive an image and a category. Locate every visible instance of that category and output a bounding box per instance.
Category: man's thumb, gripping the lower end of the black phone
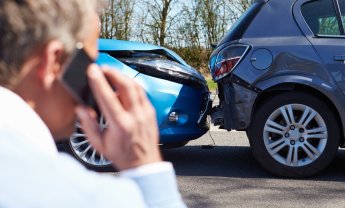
[76,106,104,152]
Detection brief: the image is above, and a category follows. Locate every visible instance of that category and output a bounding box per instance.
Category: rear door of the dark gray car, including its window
[295,0,345,94]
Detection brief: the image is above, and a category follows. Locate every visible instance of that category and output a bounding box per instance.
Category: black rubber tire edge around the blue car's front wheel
[62,139,116,172]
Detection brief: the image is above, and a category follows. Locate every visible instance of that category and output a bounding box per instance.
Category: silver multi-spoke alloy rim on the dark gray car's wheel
[263,104,328,167]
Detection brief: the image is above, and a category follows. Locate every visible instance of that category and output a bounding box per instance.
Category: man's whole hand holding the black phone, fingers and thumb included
[76,65,162,170]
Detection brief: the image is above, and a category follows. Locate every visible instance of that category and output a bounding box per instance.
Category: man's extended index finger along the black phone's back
[87,65,123,121]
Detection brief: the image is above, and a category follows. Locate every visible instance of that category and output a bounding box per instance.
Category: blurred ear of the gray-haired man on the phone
[37,40,65,89]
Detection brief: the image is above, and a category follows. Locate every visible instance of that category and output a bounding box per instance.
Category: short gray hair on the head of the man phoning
[0,0,97,86]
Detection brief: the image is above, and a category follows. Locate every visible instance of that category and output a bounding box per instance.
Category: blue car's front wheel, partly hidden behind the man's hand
[63,115,114,172]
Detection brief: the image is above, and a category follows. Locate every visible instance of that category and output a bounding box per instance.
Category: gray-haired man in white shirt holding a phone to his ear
[0,0,185,208]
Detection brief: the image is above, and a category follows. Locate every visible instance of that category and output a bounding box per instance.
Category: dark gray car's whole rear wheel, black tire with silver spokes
[247,92,340,178]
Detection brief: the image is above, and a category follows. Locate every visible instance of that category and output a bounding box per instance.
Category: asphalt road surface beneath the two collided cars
[163,129,345,208]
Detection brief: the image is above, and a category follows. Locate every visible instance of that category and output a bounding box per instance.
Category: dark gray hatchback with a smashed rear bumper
[209,0,345,177]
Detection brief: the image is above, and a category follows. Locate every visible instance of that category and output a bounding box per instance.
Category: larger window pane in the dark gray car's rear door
[302,0,340,35]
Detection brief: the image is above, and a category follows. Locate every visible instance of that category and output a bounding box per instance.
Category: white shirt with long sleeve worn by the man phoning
[0,87,185,208]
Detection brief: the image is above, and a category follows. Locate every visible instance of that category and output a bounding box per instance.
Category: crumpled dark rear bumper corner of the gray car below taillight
[211,75,260,131]
